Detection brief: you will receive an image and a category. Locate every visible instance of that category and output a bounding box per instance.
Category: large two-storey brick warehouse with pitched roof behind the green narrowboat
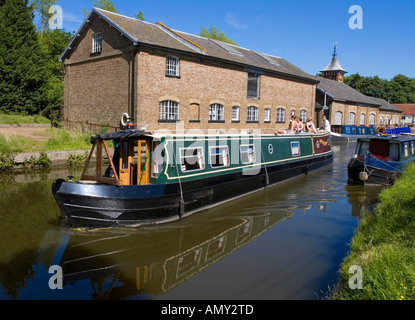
[61,8,318,133]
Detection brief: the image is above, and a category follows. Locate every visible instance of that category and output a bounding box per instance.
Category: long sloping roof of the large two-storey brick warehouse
[60,8,317,83]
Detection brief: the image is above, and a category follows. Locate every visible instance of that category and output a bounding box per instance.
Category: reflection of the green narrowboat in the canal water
[60,205,293,299]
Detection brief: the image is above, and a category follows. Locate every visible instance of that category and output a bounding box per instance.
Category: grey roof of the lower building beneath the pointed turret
[315,76,381,106]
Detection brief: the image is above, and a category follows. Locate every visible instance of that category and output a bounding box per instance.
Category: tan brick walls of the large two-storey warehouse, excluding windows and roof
[64,18,316,133]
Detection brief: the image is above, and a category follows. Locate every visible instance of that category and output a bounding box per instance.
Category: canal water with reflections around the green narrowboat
[0,143,380,300]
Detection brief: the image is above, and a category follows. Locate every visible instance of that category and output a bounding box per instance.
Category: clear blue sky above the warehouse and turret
[57,0,415,79]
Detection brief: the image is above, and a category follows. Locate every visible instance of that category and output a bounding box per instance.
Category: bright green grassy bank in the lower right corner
[330,164,415,300]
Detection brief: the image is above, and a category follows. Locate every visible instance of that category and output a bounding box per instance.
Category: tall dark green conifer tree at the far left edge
[0,0,51,114]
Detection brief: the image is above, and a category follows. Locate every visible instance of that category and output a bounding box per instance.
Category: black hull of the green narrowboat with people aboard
[52,153,333,228]
